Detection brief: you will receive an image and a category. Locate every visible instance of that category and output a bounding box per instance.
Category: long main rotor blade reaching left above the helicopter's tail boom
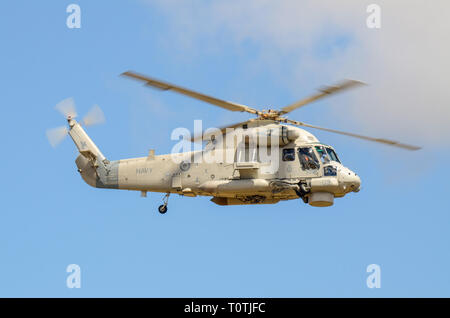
[121,71,258,114]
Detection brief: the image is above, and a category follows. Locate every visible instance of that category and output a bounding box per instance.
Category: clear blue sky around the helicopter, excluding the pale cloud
[0,0,450,297]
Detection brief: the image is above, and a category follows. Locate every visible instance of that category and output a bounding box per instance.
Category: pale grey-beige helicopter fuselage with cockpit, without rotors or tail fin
[76,122,360,206]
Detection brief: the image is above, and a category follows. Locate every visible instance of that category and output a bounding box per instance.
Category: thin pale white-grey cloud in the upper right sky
[149,0,450,145]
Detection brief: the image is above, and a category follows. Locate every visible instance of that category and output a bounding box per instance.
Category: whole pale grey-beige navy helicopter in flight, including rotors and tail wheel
[47,71,420,214]
